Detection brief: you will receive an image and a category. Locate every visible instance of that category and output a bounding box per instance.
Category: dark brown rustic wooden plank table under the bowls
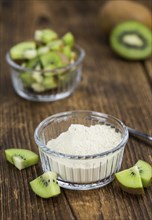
[0,0,152,220]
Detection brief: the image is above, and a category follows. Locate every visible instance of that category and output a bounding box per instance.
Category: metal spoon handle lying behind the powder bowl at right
[127,127,152,144]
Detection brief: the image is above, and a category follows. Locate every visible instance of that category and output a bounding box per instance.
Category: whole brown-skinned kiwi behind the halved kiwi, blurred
[98,0,152,35]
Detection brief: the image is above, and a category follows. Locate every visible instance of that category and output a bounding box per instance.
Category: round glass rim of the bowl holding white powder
[34,110,129,160]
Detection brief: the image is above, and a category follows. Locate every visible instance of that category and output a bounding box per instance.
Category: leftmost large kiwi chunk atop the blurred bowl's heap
[10,41,37,60]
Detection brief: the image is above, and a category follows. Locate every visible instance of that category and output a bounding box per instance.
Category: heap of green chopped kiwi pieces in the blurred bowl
[10,29,76,93]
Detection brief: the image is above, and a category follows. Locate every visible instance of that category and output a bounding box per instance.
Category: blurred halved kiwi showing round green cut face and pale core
[110,21,152,60]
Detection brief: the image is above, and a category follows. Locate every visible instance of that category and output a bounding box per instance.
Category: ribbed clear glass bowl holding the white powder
[34,110,128,190]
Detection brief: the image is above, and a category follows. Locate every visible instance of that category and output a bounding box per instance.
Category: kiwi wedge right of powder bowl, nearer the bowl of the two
[115,166,144,194]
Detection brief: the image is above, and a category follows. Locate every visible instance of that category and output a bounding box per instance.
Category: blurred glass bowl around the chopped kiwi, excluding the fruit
[6,45,85,102]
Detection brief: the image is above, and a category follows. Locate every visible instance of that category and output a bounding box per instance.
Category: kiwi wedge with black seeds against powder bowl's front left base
[30,171,60,198]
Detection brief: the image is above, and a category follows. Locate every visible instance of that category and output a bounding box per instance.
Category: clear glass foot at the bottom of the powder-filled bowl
[58,175,114,190]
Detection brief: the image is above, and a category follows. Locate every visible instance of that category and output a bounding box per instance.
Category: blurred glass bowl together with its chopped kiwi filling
[6,29,85,102]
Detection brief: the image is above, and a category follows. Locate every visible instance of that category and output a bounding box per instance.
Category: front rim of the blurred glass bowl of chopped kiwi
[6,44,85,73]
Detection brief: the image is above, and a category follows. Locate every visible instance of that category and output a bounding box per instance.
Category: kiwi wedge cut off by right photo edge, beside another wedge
[135,160,152,187]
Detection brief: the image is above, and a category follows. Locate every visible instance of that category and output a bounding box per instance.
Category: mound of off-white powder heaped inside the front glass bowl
[47,124,121,155]
